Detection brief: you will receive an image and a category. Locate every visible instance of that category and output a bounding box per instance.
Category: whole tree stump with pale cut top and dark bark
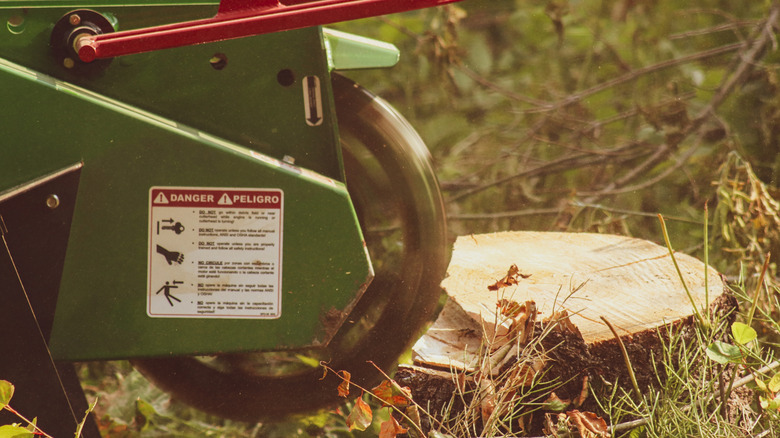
[396,232,737,436]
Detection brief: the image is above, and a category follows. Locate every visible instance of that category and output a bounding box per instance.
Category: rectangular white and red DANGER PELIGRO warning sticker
[147,187,283,318]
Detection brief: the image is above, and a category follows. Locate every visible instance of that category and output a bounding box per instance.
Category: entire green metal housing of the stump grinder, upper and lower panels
[0,1,397,360]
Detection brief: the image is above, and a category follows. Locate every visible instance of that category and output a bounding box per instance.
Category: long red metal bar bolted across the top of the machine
[75,0,459,62]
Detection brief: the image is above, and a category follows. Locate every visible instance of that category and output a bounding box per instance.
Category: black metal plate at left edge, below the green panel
[0,163,100,437]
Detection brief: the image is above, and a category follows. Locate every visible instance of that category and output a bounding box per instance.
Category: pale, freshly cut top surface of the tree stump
[414,231,724,367]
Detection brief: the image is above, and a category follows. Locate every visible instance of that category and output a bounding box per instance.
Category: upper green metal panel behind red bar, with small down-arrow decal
[0,6,343,181]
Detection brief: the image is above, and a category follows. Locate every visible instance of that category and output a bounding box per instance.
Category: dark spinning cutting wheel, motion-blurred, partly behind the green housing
[133,75,449,421]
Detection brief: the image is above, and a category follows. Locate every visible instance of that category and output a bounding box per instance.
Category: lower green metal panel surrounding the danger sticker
[0,41,371,360]
